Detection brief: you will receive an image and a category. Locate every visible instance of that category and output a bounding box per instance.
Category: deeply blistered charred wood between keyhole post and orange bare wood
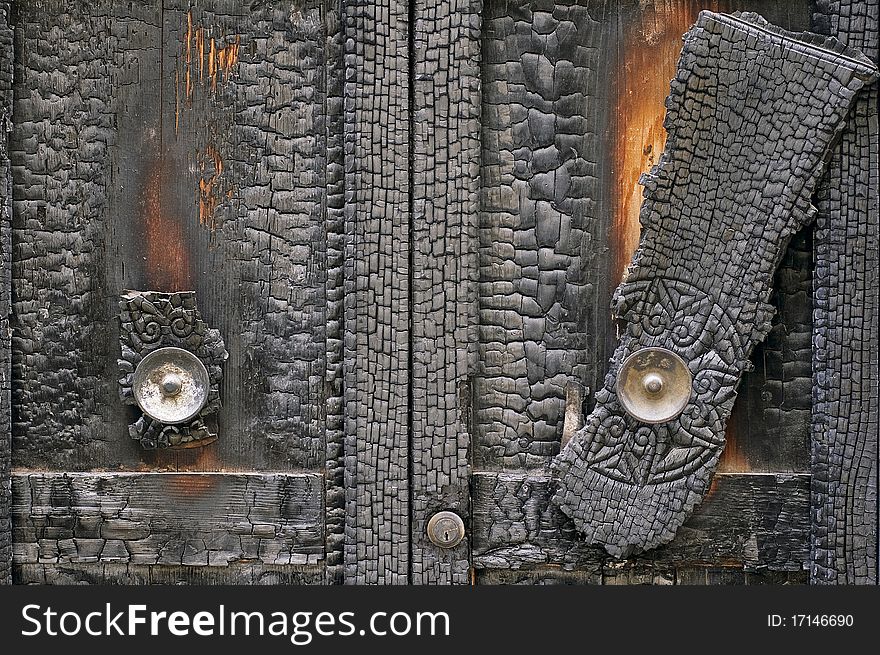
[473,0,612,469]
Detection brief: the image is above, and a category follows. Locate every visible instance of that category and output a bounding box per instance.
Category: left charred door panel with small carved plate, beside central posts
[3,0,341,583]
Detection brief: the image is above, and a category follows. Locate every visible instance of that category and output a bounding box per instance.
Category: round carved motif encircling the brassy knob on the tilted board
[582,278,742,487]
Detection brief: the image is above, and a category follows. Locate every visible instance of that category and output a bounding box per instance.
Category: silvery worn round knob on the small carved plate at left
[132,347,211,425]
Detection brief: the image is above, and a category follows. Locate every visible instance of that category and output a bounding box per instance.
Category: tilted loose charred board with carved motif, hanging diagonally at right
[553,12,877,557]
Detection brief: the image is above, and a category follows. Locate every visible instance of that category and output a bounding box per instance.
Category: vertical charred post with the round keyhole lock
[411,0,482,584]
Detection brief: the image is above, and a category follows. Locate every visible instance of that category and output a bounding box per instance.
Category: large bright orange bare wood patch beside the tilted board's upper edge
[611,0,705,285]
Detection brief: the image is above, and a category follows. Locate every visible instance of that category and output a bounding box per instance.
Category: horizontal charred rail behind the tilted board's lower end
[471,473,810,571]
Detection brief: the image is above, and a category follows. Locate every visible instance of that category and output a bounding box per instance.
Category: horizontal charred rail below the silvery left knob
[12,472,324,566]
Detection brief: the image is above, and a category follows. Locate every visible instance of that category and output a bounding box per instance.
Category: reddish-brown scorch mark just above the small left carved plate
[143,158,192,292]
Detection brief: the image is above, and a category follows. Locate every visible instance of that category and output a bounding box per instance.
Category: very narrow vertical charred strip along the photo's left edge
[0,2,14,584]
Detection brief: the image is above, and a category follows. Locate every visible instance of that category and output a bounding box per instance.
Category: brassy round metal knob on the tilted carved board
[617,348,693,423]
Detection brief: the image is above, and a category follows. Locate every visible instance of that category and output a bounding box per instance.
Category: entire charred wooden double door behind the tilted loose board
[0,0,878,584]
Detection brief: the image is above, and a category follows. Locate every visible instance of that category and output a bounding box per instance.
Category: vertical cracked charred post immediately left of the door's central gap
[344,0,411,584]
